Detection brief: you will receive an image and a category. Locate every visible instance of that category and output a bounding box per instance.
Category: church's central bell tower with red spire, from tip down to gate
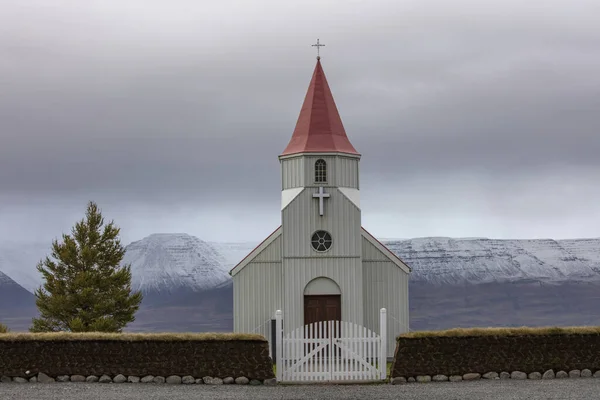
[279,57,363,332]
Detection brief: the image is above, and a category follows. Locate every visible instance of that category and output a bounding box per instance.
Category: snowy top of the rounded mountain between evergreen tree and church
[123,233,231,292]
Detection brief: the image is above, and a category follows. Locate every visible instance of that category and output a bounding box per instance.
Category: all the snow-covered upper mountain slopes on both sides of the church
[0,234,600,292]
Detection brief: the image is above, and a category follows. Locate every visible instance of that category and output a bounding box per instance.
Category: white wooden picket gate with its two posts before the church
[275,308,387,382]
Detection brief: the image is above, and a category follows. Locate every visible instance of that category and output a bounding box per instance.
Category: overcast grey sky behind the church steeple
[0,0,600,243]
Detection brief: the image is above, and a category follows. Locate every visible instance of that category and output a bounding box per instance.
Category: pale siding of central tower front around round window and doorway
[282,173,363,332]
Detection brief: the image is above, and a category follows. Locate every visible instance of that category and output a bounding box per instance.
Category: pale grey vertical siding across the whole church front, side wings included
[233,148,409,357]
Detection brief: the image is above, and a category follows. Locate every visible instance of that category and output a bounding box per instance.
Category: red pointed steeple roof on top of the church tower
[281,59,358,156]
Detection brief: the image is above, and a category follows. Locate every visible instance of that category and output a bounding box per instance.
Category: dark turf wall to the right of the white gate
[391,333,600,378]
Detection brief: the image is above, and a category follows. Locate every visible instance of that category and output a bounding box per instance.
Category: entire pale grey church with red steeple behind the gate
[230,57,410,358]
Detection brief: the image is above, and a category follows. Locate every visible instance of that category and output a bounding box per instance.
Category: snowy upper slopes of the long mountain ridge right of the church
[385,237,600,285]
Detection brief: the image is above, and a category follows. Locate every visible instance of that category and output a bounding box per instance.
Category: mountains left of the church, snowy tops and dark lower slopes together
[0,234,233,332]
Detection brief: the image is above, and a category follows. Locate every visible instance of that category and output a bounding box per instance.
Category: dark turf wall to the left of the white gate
[0,335,274,380]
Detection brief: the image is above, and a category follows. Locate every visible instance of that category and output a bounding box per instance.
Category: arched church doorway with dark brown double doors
[304,277,342,325]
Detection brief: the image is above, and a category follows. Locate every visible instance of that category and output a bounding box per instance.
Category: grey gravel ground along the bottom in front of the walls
[0,378,600,400]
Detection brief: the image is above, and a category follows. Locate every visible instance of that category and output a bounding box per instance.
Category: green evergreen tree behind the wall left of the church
[30,202,142,332]
